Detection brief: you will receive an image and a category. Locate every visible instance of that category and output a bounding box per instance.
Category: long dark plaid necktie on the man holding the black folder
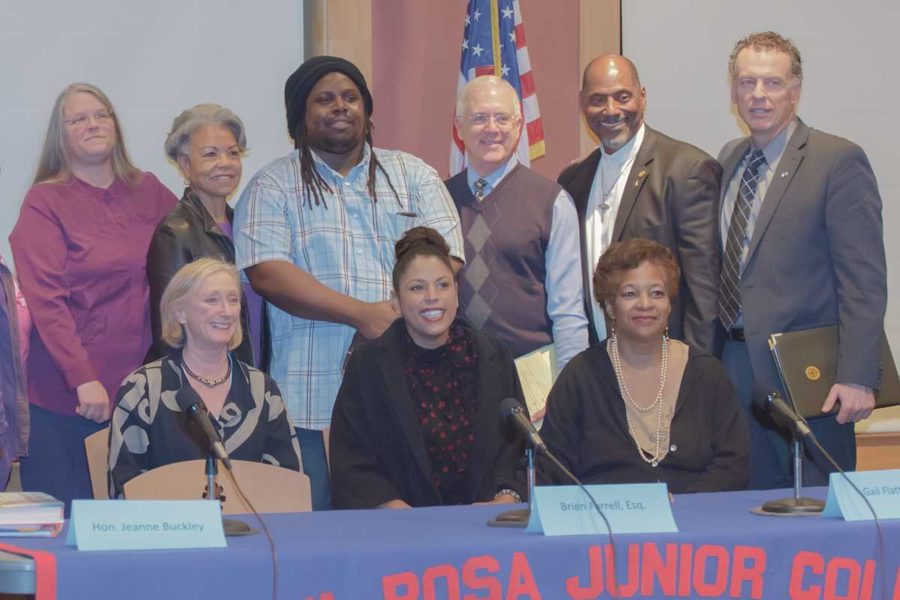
[719,149,766,330]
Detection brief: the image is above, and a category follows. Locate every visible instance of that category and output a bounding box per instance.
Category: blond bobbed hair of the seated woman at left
[159,256,244,350]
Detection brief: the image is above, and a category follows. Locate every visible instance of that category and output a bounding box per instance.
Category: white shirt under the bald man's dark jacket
[584,124,644,341]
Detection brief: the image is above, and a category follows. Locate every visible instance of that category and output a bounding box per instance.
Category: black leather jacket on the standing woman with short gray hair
[144,188,255,365]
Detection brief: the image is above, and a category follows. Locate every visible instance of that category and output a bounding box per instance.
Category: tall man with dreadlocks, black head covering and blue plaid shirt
[234,56,463,509]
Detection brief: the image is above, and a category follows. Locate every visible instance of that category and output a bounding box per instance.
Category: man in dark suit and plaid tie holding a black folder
[719,32,887,488]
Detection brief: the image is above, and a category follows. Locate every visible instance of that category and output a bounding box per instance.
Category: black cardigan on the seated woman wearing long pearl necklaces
[538,342,750,493]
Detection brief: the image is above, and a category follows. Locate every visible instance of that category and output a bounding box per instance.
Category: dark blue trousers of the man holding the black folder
[722,340,856,490]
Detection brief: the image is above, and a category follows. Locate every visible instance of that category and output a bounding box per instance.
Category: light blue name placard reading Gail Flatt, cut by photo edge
[822,469,900,521]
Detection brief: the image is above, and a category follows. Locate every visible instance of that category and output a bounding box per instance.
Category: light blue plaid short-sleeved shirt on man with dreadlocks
[234,145,463,429]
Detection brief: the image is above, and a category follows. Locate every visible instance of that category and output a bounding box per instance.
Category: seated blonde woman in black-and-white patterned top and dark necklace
[109,258,301,498]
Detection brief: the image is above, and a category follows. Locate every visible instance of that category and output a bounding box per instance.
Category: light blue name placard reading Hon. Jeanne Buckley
[66,500,226,550]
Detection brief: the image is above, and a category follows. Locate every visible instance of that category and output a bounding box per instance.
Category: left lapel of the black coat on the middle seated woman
[378,330,439,497]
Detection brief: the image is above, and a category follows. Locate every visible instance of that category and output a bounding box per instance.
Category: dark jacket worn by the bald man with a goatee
[558,126,721,353]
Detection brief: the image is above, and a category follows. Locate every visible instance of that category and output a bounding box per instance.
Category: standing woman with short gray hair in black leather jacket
[144,104,263,365]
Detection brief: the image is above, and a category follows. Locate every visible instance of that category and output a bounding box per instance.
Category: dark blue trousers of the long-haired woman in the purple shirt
[20,404,108,516]
